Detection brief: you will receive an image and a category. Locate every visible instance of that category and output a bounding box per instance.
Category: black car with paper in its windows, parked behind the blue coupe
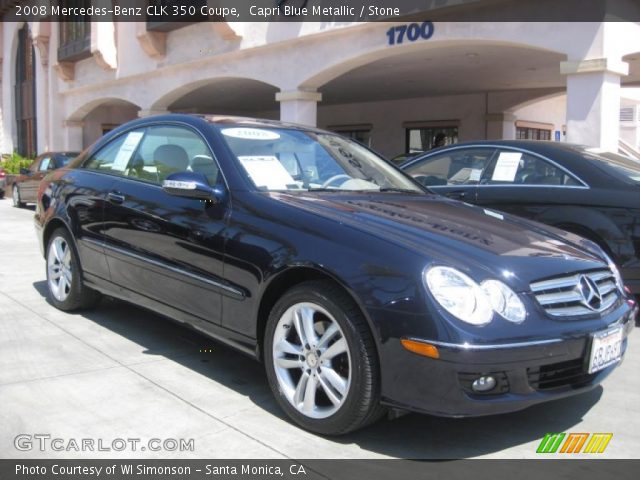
[401,140,640,295]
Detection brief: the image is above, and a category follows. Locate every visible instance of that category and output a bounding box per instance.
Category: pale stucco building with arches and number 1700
[0,2,640,160]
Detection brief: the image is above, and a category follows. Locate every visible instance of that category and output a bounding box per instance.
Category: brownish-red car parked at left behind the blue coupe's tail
[11,152,78,208]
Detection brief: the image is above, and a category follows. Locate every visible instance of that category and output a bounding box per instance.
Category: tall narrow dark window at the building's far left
[15,24,38,157]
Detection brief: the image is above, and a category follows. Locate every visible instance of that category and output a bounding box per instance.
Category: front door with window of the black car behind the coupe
[403,146,495,203]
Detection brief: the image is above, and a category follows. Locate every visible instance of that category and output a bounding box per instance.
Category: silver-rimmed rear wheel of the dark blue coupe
[46,228,100,312]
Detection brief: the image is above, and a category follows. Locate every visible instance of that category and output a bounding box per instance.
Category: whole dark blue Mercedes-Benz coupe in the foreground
[35,114,637,435]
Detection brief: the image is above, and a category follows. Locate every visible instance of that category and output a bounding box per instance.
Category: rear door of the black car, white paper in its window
[476,147,588,219]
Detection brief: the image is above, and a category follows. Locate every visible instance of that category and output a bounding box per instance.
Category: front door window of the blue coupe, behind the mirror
[126,125,219,185]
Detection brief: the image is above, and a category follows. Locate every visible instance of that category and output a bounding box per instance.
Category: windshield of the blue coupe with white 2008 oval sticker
[220,126,423,193]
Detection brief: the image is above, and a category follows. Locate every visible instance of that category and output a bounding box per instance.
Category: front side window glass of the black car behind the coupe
[407,148,495,187]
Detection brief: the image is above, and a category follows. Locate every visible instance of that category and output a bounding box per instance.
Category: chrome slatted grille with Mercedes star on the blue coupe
[530,270,620,317]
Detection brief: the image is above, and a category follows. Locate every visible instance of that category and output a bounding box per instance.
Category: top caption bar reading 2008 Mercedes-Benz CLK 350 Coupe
[0,0,640,23]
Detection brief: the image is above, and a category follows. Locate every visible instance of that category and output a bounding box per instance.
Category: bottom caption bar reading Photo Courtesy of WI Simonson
[0,459,640,480]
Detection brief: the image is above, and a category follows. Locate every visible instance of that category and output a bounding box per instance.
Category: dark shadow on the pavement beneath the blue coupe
[33,281,603,459]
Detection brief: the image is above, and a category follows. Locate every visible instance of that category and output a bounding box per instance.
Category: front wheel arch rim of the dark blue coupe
[256,265,380,361]
